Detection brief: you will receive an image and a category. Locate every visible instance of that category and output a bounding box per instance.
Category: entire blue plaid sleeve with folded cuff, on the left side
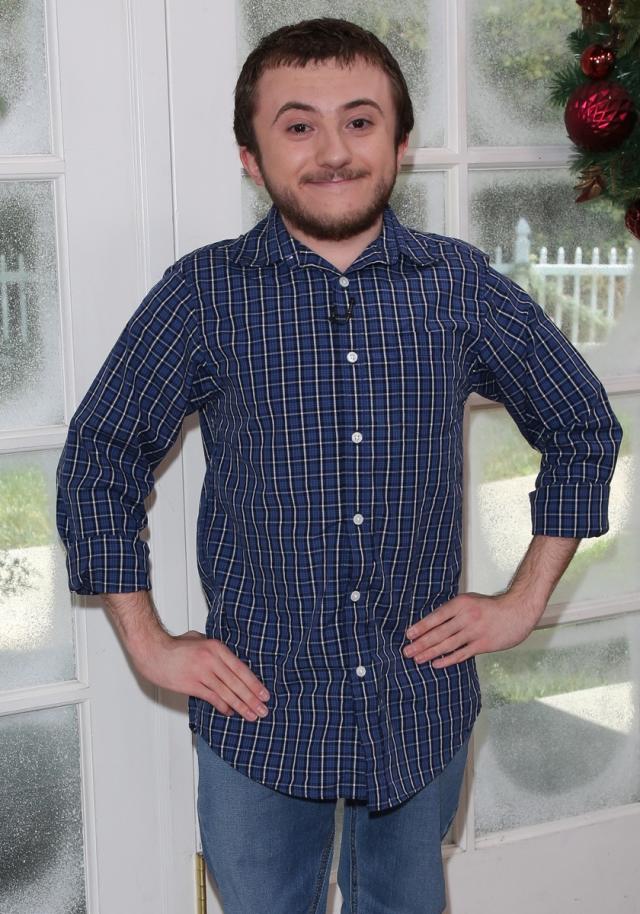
[56,262,216,594]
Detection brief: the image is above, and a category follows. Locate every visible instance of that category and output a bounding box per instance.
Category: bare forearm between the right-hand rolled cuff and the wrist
[505,534,580,624]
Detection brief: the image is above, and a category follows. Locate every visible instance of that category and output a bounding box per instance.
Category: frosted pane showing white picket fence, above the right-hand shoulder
[469,168,640,377]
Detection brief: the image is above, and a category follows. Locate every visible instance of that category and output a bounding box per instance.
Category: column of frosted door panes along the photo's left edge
[0,0,88,914]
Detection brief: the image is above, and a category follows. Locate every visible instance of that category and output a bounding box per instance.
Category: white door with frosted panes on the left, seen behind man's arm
[0,0,196,914]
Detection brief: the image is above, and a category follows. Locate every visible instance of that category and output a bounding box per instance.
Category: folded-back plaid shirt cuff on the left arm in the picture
[66,536,151,595]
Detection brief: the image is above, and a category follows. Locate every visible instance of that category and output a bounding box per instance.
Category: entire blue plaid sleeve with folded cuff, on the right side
[471,266,622,537]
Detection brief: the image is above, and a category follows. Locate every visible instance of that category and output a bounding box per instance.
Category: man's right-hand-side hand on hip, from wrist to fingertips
[402,592,544,668]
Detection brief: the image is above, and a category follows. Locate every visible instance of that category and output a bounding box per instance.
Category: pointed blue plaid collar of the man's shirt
[229,206,441,272]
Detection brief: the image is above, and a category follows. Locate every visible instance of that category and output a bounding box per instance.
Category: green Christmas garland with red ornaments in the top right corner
[550,0,640,238]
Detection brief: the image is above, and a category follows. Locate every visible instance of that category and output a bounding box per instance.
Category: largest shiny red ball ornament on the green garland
[564,80,638,152]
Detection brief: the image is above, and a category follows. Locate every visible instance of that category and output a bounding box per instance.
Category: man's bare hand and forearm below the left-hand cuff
[103,590,269,721]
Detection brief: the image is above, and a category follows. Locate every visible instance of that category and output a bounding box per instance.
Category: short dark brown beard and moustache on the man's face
[259,162,396,241]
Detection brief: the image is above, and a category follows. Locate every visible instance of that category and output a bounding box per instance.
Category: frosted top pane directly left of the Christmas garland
[467,0,580,146]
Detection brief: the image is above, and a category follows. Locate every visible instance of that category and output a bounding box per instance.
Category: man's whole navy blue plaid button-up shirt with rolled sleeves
[58,203,621,810]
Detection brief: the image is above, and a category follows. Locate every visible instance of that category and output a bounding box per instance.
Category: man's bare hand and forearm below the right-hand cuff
[402,534,580,668]
